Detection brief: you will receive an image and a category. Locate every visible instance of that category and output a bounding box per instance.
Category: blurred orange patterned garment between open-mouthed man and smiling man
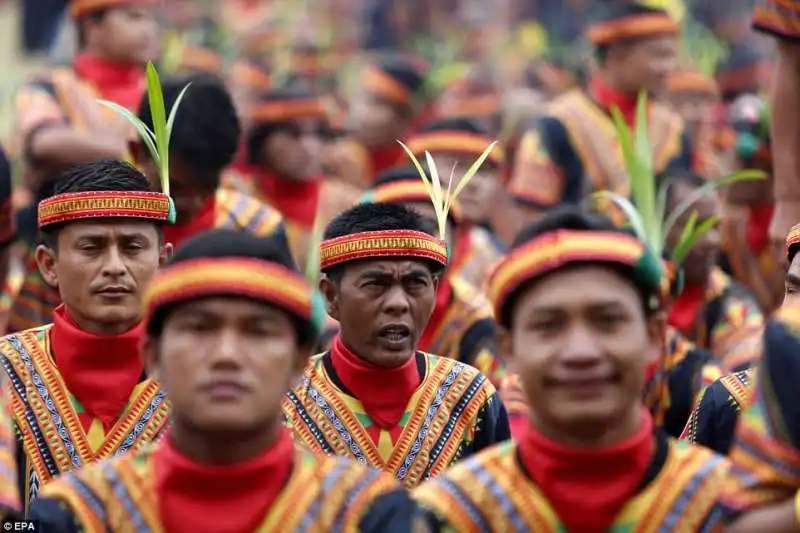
[421,276,505,386]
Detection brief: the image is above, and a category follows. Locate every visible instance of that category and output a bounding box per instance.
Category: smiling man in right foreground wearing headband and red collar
[413,208,727,533]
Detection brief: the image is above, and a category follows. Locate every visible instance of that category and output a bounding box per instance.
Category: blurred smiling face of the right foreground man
[509,266,663,435]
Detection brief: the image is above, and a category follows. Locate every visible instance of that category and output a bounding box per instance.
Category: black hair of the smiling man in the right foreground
[504,205,655,328]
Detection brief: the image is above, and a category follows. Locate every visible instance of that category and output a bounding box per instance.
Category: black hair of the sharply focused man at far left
[40,159,161,251]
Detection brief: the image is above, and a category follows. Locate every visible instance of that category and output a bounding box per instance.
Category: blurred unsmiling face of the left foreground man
[143,297,311,432]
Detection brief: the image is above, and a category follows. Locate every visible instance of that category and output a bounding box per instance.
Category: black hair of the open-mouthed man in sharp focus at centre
[324,203,443,283]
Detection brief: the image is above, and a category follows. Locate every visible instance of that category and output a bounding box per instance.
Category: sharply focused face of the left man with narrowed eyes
[36,220,167,331]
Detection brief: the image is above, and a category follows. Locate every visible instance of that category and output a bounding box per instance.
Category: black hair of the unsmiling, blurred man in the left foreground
[147,229,319,346]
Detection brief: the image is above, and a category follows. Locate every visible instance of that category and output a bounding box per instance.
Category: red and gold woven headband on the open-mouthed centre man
[320,230,447,272]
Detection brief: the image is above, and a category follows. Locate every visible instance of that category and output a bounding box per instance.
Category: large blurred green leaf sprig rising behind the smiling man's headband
[595,92,766,266]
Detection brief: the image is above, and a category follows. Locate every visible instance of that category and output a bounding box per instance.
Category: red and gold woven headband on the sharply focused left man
[38,191,174,229]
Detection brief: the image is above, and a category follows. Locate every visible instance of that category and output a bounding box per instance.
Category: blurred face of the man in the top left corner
[87,4,158,64]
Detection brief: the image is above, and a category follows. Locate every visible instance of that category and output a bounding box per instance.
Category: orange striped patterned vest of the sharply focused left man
[0,325,168,510]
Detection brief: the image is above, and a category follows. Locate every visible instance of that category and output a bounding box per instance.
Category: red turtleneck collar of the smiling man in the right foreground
[519,410,655,533]
